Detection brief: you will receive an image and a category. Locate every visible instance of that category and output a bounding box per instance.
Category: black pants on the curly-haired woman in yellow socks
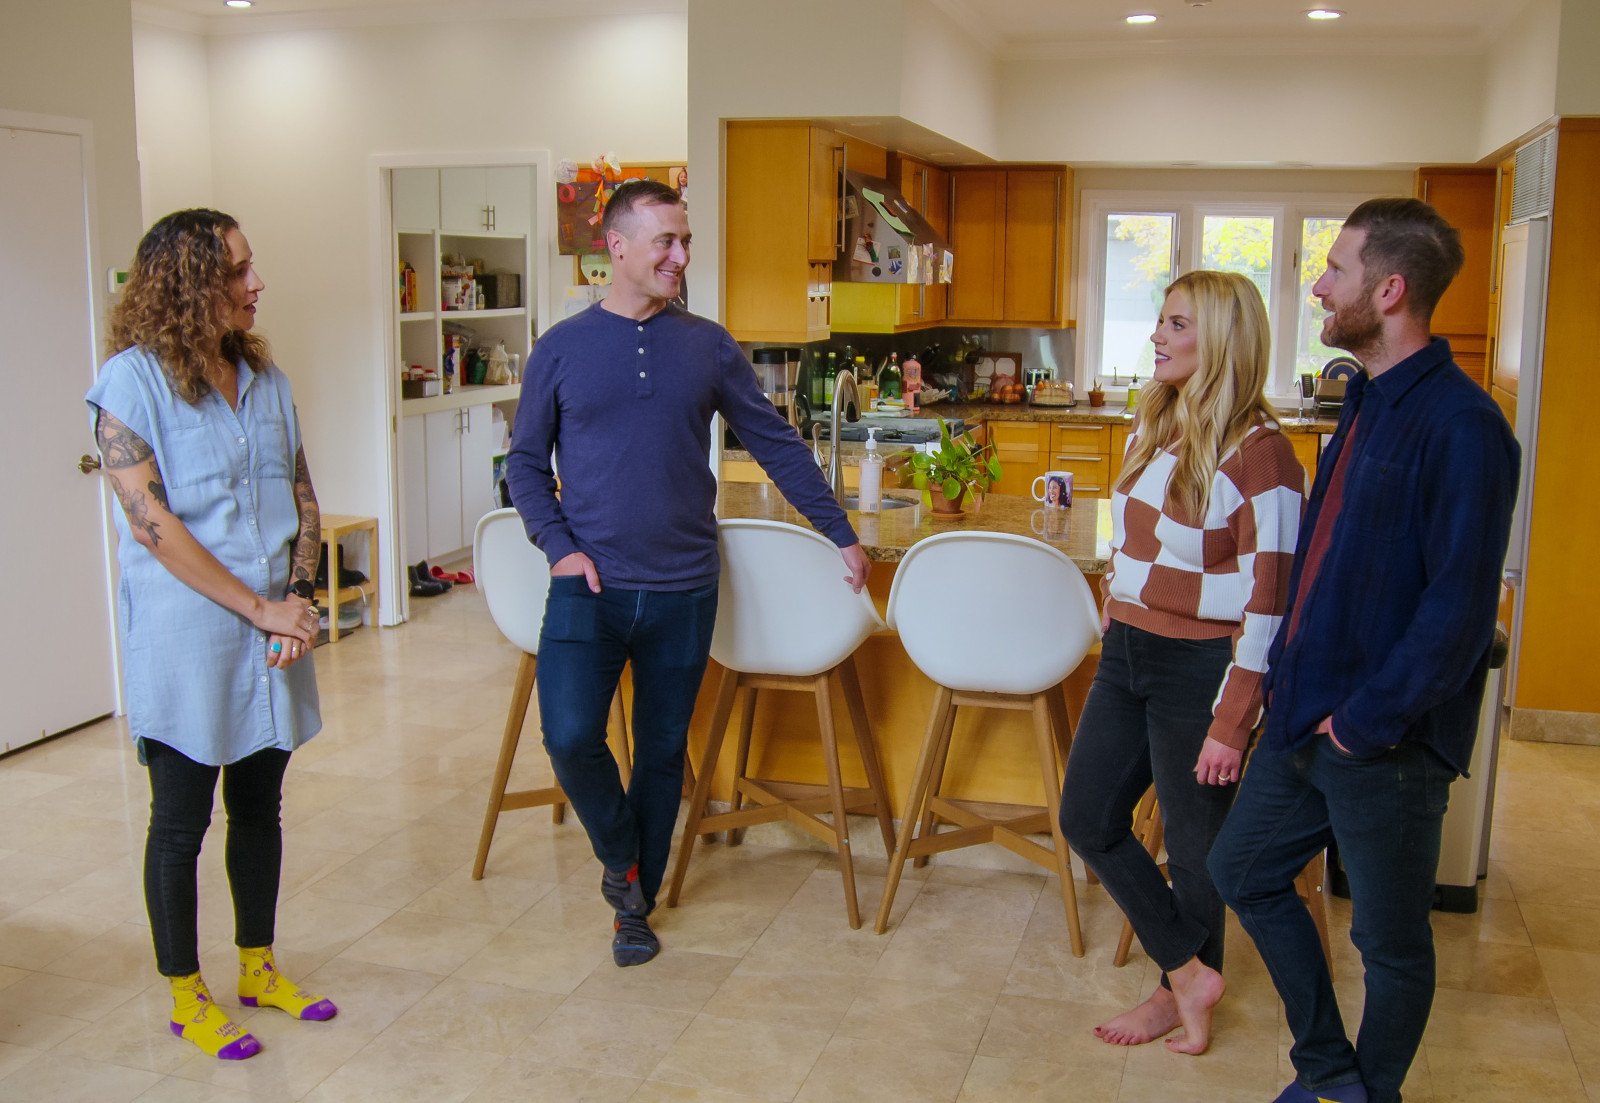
[144,740,290,977]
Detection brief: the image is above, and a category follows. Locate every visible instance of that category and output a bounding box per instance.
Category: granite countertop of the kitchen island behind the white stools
[717,482,1110,575]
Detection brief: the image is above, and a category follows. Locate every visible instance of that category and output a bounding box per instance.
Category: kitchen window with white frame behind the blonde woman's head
[1078,191,1366,397]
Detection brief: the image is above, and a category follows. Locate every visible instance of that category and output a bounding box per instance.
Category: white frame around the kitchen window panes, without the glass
[1074,189,1371,403]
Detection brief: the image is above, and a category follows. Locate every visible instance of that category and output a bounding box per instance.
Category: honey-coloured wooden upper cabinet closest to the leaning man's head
[723,122,845,343]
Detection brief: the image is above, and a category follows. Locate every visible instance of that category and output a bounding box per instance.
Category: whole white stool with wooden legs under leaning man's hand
[667,520,894,927]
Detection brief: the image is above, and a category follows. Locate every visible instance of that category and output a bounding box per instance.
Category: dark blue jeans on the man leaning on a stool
[538,575,717,906]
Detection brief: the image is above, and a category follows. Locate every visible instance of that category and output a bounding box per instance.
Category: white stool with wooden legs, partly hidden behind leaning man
[472,509,632,880]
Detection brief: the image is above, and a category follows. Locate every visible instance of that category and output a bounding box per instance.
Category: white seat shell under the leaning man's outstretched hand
[710,519,883,677]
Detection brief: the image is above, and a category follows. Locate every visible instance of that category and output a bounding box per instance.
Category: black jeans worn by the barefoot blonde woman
[1061,621,1234,970]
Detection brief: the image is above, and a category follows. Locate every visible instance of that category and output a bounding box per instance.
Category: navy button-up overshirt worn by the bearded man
[1264,338,1520,772]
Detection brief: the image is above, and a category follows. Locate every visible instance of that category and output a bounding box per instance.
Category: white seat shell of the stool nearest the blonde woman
[888,531,1099,693]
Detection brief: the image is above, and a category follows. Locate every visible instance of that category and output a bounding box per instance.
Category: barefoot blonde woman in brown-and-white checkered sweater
[1061,272,1306,1053]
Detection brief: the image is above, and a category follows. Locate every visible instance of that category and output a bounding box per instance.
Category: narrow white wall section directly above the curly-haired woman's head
[133,22,216,226]
